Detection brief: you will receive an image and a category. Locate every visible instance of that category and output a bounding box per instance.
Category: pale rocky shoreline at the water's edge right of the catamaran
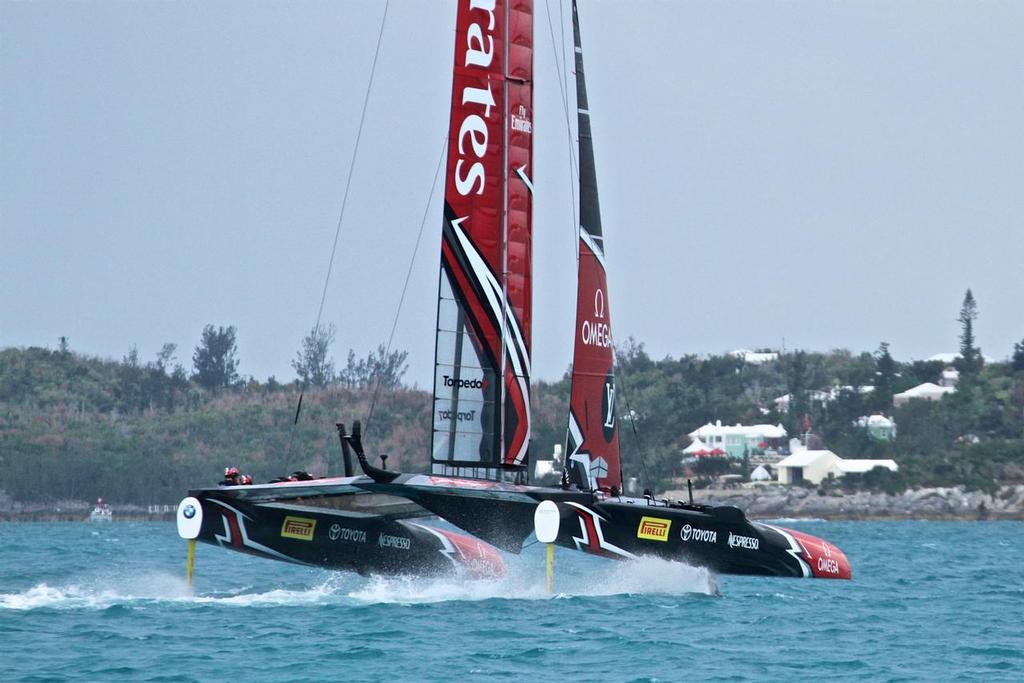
[665,484,1024,520]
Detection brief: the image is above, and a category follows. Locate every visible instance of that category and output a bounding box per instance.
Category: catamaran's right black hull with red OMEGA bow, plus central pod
[348,474,852,579]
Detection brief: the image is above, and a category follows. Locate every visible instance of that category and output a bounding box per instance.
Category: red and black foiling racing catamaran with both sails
[178,0,850,579]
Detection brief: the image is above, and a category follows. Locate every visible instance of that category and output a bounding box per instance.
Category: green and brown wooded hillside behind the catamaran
[0,292,1024,503]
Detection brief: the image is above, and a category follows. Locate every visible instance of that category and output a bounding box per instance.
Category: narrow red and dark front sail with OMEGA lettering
[565,0,623,490]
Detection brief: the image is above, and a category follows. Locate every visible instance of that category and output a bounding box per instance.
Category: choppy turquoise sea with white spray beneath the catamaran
[0,521,1024,681]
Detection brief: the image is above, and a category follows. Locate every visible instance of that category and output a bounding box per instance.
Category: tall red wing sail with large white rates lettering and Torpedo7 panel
[432,0,534,478]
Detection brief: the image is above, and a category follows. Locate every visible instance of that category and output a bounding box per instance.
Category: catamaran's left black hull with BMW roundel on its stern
[180,486,505,579]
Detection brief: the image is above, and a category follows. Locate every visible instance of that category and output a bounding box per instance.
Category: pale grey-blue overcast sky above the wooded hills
[0,0,1024,386]
